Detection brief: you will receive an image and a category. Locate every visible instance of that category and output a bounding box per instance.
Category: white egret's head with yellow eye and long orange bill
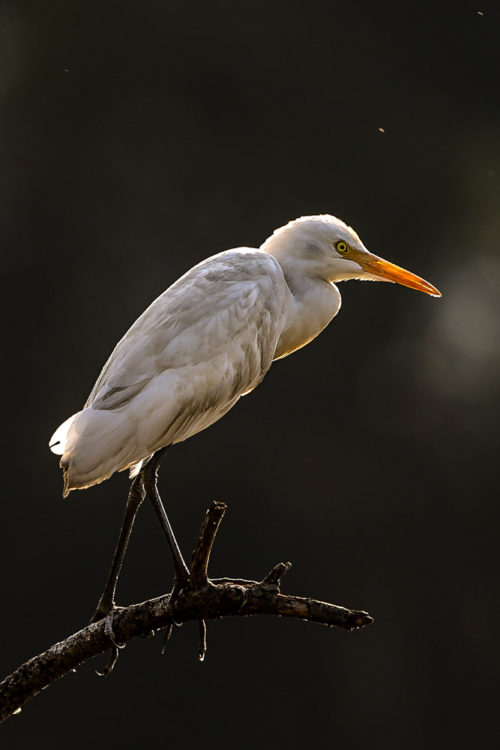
[262,214,441,297]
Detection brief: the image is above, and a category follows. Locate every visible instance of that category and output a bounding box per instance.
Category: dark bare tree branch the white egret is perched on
[0,503,373,721]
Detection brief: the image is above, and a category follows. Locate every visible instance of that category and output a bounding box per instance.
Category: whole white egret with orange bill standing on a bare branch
[50,215,441,619]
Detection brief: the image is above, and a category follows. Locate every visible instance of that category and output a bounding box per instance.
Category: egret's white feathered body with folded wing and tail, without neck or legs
[51,253,289,494]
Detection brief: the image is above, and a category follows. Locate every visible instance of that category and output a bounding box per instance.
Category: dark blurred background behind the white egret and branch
[0,0,500,750]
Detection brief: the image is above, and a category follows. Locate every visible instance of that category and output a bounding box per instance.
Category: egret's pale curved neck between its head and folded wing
[274,263,341,359]
